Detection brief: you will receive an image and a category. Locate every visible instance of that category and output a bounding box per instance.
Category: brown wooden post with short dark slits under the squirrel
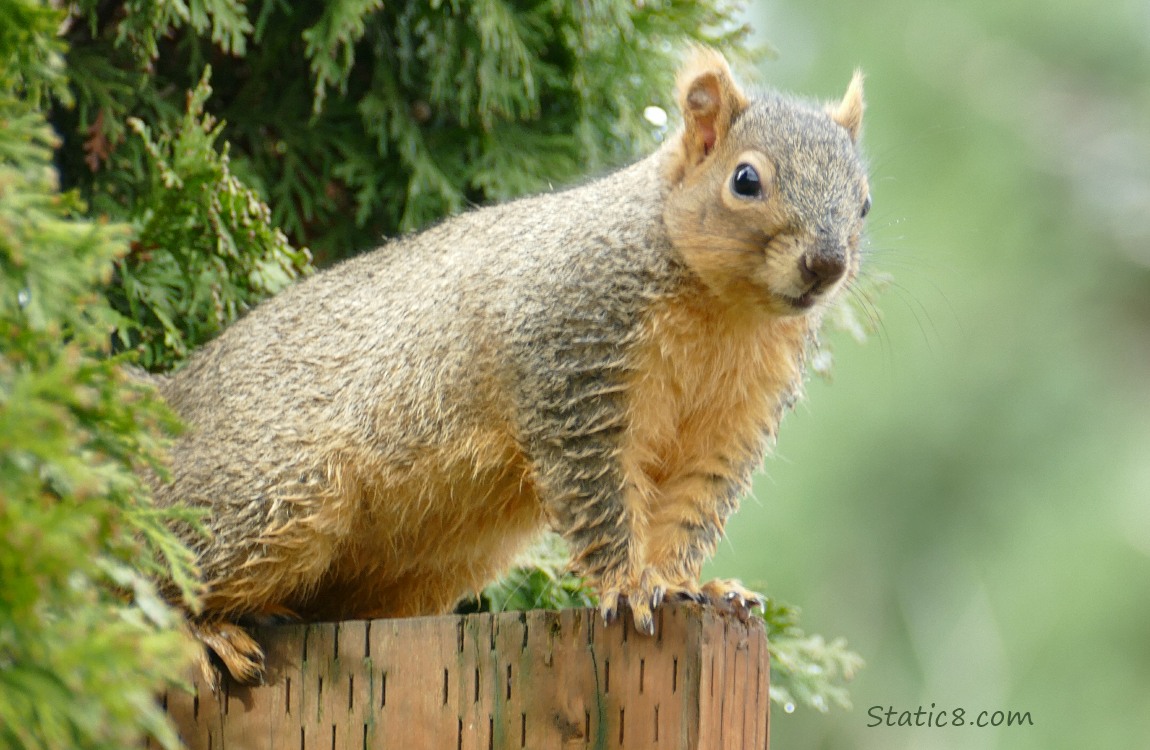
[152,603,769,750]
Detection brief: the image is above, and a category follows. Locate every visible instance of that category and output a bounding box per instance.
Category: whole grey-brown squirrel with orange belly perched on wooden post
[153,49,869,681]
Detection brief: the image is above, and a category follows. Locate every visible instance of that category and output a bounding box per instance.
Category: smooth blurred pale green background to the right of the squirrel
[708,0,1150,750]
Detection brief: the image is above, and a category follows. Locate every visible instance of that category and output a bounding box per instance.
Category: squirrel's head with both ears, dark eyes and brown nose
[664,49,871,315]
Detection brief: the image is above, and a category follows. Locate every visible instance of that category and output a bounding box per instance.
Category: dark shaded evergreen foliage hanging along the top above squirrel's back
[59,0,745,259]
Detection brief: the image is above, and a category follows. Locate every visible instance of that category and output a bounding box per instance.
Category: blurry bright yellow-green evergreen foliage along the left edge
[0,0,193,749]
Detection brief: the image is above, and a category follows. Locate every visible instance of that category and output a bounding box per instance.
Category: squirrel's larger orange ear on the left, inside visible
[676,47,748,166]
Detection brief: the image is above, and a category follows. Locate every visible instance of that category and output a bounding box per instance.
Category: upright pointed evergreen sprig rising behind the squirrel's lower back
[109,68,311,367]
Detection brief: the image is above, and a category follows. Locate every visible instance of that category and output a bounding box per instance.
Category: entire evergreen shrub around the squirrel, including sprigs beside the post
[0,0,864,748]
